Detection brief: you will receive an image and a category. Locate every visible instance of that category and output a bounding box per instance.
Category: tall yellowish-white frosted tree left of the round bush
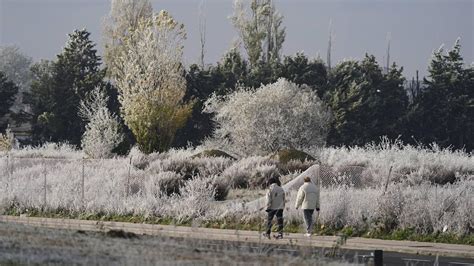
[116,11,193,153]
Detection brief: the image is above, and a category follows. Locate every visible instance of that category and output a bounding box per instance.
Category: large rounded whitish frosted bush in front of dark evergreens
[204,79,331,155]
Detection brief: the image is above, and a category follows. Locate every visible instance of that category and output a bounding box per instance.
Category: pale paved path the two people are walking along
[0,216,474,259]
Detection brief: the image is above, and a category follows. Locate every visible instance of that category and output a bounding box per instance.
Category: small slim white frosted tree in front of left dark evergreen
[79,87,123,158]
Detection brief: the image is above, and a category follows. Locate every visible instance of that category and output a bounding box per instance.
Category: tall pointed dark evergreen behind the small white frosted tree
[31,30,105,145]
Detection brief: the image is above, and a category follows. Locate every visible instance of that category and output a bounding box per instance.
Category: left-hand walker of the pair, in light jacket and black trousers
[263,178,285,239]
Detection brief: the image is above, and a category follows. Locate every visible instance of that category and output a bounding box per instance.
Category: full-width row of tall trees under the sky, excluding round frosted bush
[0,0,474,153]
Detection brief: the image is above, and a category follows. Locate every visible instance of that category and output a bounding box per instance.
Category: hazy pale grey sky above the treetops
[0,0,474,77]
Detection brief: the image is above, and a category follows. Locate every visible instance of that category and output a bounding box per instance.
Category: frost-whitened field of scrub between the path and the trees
[0,142,474,235]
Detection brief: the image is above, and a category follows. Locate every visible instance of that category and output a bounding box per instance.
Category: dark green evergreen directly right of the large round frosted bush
[329,55,408,145]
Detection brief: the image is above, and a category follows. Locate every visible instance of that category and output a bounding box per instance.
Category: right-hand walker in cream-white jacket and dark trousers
[295,176,319,237]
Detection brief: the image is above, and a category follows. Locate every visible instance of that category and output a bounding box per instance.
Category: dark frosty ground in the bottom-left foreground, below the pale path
[0,223,360,265]
